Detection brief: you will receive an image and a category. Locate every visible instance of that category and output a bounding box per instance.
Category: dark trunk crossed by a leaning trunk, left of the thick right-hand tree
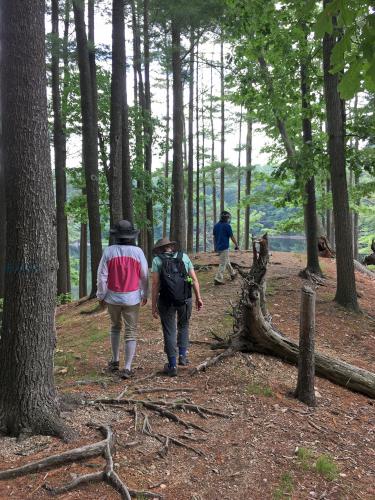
[301,59,322,275]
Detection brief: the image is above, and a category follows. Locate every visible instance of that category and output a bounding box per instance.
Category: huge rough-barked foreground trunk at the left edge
[0,0,63,436]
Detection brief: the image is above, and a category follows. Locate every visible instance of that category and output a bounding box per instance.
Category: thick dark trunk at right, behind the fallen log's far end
[323,0,359,311]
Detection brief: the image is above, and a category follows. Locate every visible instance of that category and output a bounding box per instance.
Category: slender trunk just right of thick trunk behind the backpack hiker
[187,28,194,252]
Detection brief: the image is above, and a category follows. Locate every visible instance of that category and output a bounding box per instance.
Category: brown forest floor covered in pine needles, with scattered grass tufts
[0,252,375,500]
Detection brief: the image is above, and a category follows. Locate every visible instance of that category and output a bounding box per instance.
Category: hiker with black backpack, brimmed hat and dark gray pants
[152,238,203,377]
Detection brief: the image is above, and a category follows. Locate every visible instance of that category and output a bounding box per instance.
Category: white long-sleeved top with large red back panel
[96,245,148,306]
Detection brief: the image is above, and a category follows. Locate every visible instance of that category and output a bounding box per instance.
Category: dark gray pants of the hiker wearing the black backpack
[158,299,193,357]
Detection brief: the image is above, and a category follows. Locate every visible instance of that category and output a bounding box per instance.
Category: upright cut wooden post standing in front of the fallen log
[295,285,316,406]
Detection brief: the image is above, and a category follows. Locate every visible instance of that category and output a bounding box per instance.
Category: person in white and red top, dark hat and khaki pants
[97,220,148,379]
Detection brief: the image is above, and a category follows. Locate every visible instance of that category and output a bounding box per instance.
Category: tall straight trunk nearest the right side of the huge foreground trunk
[51,0,70,295]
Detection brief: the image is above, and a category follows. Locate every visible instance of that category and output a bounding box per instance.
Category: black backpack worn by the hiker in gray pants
[159,252,191,307]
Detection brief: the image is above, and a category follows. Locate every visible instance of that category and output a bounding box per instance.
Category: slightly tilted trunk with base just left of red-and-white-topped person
[73,0,102,297]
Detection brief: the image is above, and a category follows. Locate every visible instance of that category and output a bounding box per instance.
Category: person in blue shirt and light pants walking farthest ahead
[213,210,238,285]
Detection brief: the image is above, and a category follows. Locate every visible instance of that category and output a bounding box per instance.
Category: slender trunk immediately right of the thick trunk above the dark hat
[122,22,134,222]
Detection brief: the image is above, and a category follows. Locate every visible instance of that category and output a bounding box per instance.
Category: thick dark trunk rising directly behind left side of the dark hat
[109,0,125,225]
